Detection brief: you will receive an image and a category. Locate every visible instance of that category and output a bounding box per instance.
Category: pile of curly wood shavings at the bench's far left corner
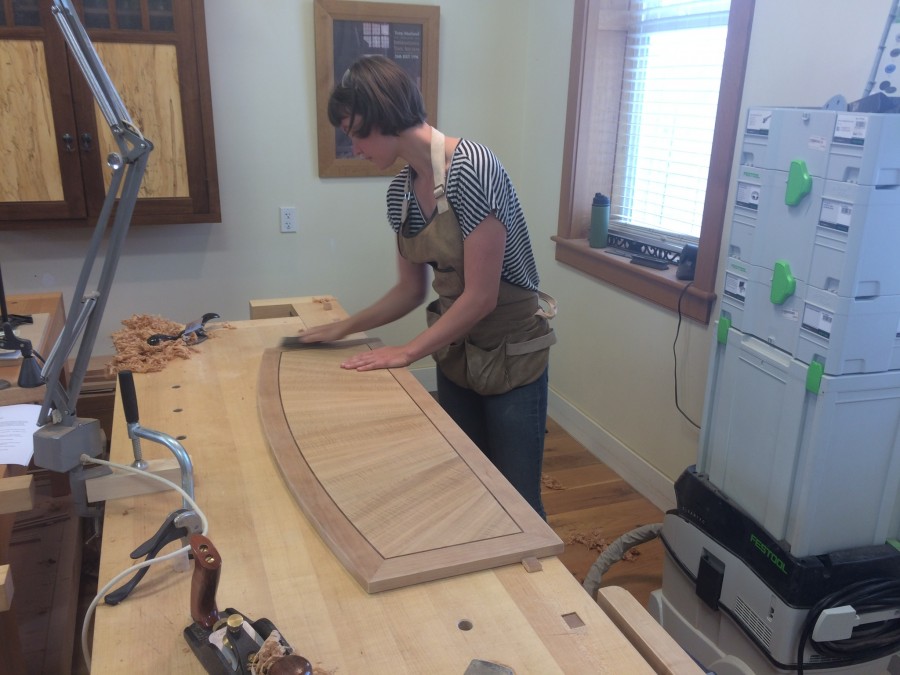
[106,314,227,375]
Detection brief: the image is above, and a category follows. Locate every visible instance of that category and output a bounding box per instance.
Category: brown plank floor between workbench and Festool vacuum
[542,420,663,607]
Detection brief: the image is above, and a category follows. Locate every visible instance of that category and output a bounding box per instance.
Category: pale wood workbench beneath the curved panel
[92,297,702,675]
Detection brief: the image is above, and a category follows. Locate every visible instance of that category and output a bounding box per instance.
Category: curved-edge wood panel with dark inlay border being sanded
[259,345,564,592]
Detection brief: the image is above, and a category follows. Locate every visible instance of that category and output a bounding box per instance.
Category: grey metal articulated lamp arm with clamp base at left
[23,0,153,482]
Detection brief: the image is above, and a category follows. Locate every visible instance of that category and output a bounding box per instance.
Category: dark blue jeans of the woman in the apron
[437,367,547,520]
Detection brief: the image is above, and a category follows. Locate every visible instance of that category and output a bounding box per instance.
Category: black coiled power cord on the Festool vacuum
[797,579,900,675]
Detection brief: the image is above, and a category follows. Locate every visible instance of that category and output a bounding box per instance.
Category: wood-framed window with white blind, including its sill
[554,0,753,322]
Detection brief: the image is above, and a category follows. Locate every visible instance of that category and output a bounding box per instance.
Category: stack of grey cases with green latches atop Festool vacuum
[651,108,900,675]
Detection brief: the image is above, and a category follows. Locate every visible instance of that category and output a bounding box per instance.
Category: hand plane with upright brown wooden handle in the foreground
[184,534,312,675]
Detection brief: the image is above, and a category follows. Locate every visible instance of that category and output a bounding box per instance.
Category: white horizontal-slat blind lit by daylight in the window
[611,0,730,245]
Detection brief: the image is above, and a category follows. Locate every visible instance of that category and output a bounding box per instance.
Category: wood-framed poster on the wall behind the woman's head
[315,0,440,178]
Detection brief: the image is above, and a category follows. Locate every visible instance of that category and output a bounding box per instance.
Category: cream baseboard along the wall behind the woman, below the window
[410,366,675,511]
